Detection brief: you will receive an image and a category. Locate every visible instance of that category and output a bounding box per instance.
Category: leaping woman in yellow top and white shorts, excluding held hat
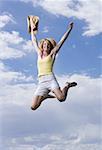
[30,17,77,110]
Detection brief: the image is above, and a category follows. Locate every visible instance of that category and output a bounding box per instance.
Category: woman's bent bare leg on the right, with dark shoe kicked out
[53,82,77,102]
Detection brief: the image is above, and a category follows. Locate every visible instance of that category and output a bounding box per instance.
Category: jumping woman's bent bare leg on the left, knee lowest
[31,94,56,110]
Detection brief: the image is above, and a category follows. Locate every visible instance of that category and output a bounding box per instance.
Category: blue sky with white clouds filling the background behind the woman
[0,0,102,150]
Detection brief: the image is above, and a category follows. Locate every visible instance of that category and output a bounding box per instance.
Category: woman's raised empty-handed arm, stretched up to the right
[51,22,73,54]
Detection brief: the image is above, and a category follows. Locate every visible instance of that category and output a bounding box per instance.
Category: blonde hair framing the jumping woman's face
[38,38,56,51]
